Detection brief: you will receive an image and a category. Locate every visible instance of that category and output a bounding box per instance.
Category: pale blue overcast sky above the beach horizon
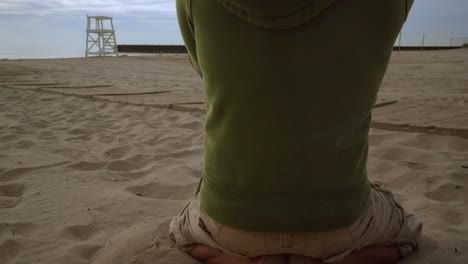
[0,0,468,58]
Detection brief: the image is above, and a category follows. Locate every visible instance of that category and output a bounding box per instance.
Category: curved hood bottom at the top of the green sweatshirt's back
[217,0,335,29]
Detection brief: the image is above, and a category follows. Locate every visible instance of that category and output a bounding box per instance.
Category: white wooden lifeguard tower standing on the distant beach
[85,16,118,57]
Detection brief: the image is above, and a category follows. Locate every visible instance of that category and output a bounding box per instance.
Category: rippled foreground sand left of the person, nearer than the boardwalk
[0,89,203,263]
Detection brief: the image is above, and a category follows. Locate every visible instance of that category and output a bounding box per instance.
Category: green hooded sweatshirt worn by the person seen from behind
[177,0,412,232]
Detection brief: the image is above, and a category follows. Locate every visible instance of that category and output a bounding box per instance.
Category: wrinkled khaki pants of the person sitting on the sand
[170,185,422,262]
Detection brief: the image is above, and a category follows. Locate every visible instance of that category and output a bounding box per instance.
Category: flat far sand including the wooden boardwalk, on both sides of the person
[0,49,468,130]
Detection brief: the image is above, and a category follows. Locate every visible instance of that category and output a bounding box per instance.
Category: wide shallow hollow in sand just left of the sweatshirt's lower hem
[126,182,198,200]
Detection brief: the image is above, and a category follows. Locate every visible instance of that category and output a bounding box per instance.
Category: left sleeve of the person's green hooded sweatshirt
[176,0,203,78]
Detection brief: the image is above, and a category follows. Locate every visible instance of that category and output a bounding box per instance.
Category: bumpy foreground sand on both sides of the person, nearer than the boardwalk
[0,89,468,264]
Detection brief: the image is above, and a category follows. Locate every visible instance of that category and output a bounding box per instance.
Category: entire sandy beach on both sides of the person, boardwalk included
[0,49,468,264]
